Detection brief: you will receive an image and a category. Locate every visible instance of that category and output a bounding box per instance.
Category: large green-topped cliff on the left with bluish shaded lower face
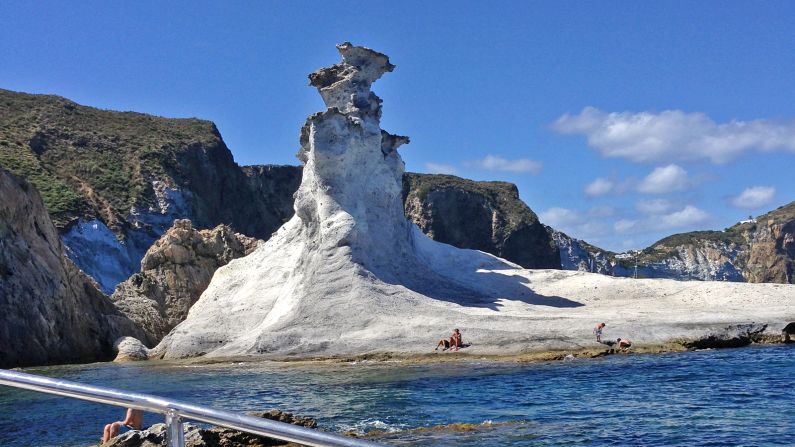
[0,89,290,294]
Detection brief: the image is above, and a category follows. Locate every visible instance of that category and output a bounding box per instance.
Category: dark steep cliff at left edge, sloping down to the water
[0,169,141,368]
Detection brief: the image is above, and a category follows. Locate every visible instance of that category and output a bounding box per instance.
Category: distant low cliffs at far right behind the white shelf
[550,202,795,284]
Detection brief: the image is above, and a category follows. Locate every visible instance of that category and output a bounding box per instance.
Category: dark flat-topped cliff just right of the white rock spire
[403,173,560,269]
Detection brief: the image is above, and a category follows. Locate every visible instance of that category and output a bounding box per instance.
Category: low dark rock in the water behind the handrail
[102,410,317,447]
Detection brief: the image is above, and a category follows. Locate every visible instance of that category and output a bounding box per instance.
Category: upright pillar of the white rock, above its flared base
[295,42,409,262]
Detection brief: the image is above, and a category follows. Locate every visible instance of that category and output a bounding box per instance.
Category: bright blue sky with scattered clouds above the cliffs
[0,1,795,251]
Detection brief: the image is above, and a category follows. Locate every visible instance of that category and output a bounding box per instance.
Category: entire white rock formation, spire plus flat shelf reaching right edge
[150,43,795,358]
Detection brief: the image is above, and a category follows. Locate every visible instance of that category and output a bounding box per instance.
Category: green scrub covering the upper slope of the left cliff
[0,89,225,233]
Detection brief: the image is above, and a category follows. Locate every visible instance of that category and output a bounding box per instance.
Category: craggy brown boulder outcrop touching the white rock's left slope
[111,219,258,346]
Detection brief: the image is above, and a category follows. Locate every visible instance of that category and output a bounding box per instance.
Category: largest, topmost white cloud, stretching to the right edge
[552,107,795,163]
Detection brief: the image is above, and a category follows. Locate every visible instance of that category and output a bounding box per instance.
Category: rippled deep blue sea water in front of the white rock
[0,345,795,446]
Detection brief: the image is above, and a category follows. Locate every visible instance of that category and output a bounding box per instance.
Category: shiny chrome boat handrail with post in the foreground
[0,369,386,447]
